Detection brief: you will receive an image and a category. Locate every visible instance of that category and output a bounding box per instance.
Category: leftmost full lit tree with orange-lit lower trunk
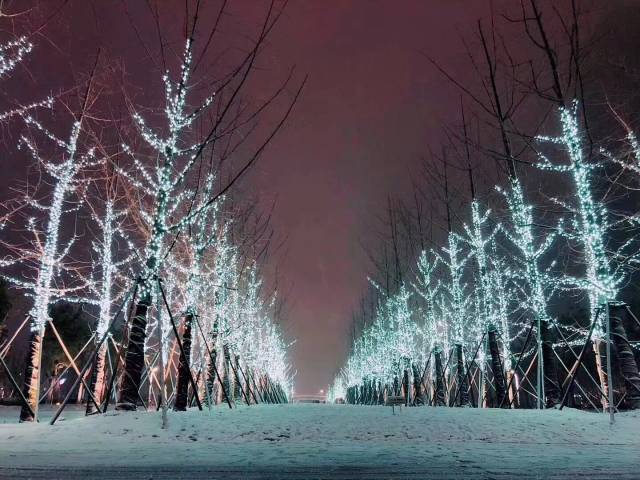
[3,102,98,421]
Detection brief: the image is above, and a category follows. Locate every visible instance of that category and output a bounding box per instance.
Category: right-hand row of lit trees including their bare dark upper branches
[335,0,640,408]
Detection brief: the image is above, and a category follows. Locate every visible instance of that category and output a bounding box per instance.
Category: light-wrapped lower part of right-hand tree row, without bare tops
[331,102,640,408]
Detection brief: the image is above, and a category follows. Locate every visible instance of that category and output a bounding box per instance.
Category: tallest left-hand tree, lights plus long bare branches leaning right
[117,3,304,410]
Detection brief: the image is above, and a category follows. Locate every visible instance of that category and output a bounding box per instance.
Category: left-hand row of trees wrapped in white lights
[0,2,302,421]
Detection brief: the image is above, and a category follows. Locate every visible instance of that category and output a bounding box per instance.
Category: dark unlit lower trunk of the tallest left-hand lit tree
[116,295,151,410]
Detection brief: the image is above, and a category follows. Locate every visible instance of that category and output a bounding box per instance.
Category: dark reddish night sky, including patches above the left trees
[1,0,632,394]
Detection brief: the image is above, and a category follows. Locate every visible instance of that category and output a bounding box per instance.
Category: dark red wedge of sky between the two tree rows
[242,0,488,393]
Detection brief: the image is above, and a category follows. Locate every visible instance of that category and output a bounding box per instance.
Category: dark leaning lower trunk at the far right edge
[609,304,640,410]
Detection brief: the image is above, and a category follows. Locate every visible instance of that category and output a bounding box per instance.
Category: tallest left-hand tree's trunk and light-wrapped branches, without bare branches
[112,40,218,410]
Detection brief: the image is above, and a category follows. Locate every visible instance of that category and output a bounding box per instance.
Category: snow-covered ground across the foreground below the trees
[0,405,640,480]
